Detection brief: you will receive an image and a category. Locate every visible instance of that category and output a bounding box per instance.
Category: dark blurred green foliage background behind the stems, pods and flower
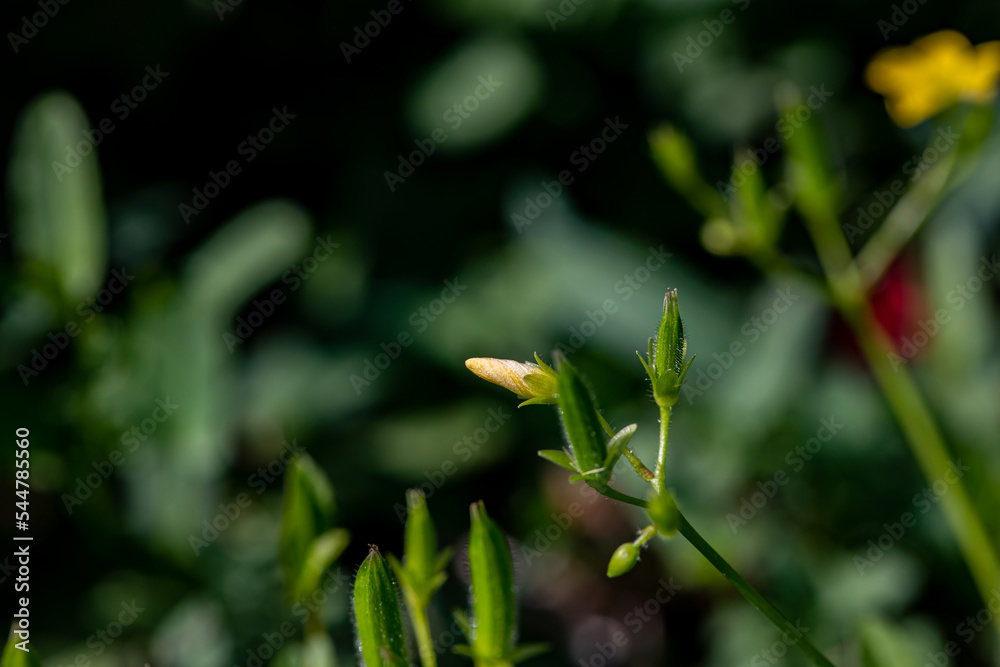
[0,0,1000,667]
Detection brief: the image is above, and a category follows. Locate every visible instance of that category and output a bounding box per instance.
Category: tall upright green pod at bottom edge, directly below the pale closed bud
[469,501,517,662]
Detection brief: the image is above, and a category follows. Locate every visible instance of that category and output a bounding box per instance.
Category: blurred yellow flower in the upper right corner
[865,30,1000,127]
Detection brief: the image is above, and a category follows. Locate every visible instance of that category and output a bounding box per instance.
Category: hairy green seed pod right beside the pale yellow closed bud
[554,354,608,474]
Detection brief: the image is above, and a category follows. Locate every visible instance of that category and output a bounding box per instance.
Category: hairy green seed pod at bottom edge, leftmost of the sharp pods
[354,546,406,667]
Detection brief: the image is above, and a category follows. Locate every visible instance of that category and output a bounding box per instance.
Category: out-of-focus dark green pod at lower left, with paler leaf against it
[279,454,334,602]
